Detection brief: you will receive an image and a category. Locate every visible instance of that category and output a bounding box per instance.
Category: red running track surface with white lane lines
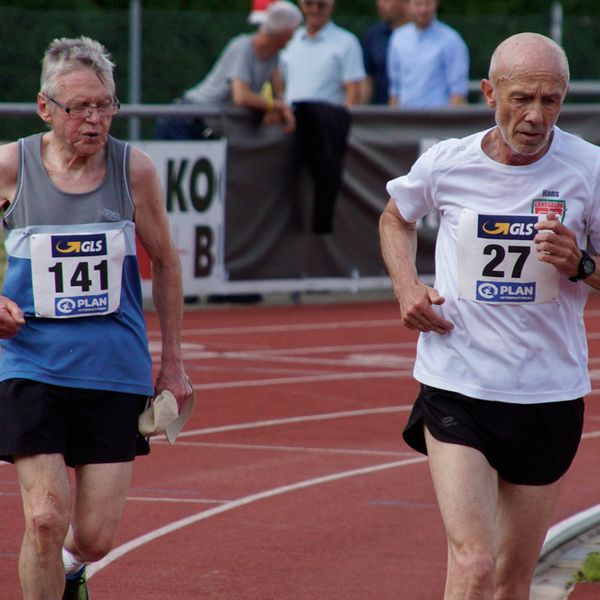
[0,295,600,600]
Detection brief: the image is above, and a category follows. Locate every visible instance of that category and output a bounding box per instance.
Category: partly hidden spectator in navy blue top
[363,0,410,104]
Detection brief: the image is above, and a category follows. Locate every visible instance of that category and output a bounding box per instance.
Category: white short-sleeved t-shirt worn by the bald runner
[387,127,600,404]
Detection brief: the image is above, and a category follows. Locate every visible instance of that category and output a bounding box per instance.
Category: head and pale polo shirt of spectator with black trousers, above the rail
[280,0,365,106]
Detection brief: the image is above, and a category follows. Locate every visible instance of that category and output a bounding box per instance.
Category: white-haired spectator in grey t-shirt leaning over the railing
[156,0,302,140]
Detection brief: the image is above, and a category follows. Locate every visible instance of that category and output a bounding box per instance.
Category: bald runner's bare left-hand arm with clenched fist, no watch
[379,199,454,333]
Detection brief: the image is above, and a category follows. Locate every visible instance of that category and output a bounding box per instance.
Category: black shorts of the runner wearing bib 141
[0,379,150,467]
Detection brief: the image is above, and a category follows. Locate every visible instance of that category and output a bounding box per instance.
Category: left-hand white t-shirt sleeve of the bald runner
[386,146,436,223]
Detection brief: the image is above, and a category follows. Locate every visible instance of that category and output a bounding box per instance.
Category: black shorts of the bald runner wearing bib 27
[403,385,584,485]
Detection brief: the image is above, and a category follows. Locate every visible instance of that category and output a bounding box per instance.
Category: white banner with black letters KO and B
[132,140,226,298]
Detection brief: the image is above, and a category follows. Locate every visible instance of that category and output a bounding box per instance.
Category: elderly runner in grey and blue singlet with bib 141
[0,37,192,600]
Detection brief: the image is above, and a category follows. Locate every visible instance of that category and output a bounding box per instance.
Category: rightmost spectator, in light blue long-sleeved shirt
[388,0,469,108]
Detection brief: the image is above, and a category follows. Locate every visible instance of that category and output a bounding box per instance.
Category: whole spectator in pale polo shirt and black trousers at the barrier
[281,0,365,234]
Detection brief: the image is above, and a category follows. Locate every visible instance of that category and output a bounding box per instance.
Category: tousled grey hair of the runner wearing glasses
[40,35,115,96]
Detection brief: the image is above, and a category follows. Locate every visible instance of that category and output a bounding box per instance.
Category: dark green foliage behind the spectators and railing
[0,0,600,140]
